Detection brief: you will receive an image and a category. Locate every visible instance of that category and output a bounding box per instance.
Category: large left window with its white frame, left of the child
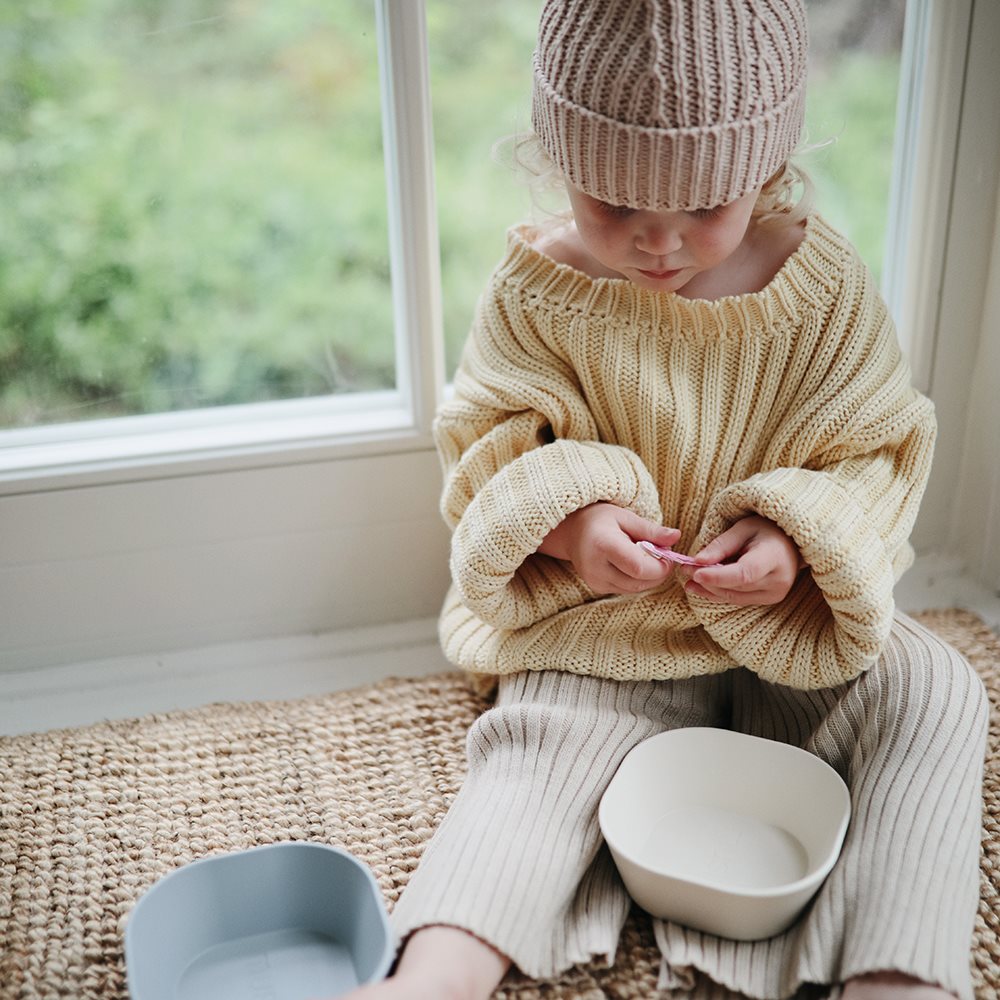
[0,0,441,489]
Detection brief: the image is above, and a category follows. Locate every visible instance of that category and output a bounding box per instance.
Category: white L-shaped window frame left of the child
[0,0,444,496]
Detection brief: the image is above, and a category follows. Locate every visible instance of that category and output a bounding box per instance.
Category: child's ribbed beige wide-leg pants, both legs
[393,615,988,1000]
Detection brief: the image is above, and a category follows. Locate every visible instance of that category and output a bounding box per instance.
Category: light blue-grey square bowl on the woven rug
[125,841,395,1000]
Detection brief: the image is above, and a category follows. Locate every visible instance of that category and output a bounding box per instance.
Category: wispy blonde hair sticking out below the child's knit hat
[493,132,815,227]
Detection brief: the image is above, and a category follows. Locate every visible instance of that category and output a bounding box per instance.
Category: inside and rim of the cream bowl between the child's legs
[600,728,850,895]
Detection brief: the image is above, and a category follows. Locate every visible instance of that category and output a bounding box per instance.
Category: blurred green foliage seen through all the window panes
[0,0,898,427]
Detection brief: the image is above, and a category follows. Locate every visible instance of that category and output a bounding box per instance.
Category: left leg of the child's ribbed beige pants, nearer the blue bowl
[392,672,728,978]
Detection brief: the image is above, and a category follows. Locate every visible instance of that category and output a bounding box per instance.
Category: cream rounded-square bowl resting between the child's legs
[599,727,851,941]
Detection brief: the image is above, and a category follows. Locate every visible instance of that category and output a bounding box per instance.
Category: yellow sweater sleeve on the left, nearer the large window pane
[434,279,661,629]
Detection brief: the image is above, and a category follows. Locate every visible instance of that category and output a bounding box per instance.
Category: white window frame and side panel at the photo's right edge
[886,0,1000,592]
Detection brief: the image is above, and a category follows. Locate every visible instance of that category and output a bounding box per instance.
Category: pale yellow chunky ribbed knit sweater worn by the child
[435,216,935,688]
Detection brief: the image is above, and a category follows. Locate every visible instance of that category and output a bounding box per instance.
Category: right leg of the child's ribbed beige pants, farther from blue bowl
[657,615,989,998]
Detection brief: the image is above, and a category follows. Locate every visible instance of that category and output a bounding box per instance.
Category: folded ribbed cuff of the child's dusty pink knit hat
[531,64,805,210]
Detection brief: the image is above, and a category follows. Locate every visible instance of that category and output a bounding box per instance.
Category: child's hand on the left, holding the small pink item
[538,503,681,594]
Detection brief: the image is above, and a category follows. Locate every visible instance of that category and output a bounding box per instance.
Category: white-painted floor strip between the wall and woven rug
[0,558,1000,735]
